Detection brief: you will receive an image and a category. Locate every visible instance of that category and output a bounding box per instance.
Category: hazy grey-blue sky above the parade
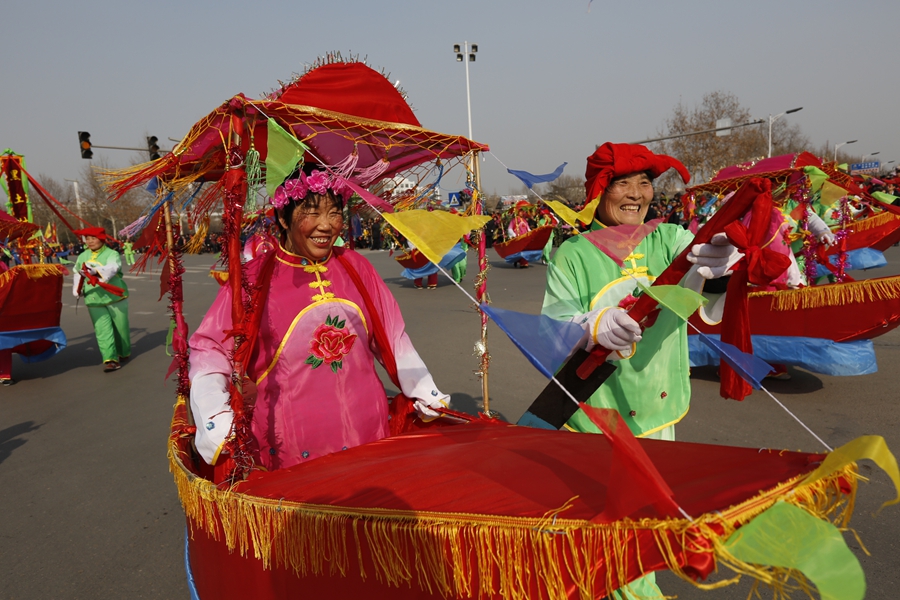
[0,0,900,194]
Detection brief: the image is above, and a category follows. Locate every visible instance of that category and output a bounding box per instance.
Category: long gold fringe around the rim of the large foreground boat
[168,399,858,600]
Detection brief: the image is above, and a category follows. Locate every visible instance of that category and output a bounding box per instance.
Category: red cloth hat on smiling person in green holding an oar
[584,142,691,202]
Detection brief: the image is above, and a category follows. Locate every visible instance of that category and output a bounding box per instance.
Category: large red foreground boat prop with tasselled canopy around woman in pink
[100,60,900,600]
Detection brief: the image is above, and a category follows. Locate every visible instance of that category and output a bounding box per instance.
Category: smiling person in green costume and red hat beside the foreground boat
[541,143,740,599]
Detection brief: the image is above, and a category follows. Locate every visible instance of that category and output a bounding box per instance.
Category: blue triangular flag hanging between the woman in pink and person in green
[481,304,584,379]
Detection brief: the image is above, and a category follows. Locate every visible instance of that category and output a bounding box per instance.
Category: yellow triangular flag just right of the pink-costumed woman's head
[382,210,491,264]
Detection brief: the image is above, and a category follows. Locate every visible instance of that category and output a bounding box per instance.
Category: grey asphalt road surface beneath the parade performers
[0,248,900,600]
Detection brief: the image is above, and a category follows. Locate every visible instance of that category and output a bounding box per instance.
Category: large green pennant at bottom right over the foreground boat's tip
[724,502,866,600]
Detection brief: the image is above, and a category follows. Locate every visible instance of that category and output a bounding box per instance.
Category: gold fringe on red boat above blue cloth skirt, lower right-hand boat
[749,275,900,311]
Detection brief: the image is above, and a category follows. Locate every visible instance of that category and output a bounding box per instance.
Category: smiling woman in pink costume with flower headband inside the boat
[190,170,449,470]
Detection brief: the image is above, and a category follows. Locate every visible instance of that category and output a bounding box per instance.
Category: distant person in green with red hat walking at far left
[72,227,131,373]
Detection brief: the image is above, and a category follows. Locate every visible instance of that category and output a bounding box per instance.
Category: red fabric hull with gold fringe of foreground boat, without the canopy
[169,401,884,600]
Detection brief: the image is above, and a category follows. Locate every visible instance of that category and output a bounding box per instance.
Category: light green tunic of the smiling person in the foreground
[541,221,693,437]
